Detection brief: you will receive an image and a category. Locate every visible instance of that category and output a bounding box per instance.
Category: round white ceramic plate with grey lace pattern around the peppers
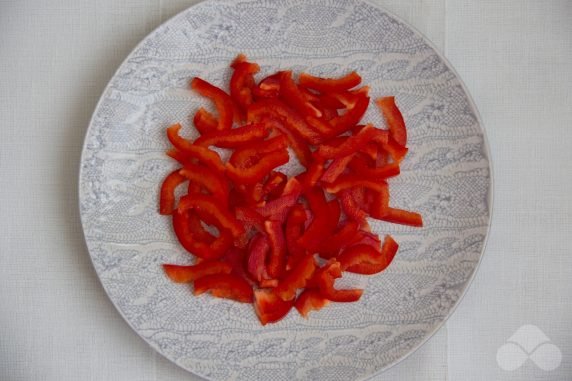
[79,0,491,381]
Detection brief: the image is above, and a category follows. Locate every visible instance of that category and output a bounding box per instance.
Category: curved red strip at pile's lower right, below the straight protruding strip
[339,235,399,275]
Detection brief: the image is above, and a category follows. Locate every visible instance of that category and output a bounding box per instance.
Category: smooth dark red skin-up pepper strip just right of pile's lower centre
[298,188,340,250]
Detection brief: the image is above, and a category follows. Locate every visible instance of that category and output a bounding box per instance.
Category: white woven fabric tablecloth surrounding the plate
[0,0,572,381]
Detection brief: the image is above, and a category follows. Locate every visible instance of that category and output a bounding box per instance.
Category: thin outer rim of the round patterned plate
[77,0,494,381]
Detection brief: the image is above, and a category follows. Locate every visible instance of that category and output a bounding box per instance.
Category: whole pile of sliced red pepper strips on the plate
[160,55,422,324]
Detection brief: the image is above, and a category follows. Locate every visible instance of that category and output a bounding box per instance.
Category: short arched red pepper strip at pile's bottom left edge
[194,274,253,303]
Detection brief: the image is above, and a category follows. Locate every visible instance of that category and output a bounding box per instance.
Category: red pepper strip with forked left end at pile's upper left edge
[167,124,224,172]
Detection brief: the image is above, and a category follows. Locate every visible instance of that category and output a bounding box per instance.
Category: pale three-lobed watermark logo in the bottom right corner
[497,324,562,371]
